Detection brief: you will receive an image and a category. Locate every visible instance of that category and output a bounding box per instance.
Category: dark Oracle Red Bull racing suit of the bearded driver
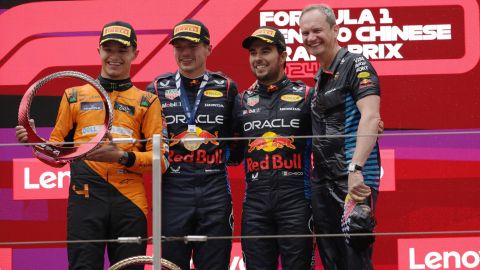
[234,77,313,269]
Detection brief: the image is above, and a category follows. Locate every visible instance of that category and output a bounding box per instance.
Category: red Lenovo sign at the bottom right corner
[398,237,480,270]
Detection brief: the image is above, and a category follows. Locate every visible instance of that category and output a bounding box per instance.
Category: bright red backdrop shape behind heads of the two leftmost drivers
[0,0,257,85]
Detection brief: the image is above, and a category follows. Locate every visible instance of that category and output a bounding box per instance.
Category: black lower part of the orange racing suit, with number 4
[67,161,147,270]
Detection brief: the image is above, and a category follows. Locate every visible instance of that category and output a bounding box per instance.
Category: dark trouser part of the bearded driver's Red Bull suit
[242,186,313,270]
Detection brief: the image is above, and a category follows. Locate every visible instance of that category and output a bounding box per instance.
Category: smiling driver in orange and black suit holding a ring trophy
[16,22,168,269]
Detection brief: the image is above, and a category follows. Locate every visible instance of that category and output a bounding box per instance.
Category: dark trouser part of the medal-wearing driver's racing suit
[162,175,233,270]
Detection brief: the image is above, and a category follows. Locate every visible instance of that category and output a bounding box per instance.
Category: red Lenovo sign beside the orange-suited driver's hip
[13,159,70,200]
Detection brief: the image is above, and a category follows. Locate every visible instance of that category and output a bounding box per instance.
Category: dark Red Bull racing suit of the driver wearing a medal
[147,72,237,270]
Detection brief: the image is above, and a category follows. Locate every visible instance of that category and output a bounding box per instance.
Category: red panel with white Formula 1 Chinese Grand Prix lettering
[260,0,480,77]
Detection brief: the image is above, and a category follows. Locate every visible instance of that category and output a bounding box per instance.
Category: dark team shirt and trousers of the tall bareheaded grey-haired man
[312,48,380,269]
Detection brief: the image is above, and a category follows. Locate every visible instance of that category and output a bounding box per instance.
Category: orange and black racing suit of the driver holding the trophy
[50,79,168,269]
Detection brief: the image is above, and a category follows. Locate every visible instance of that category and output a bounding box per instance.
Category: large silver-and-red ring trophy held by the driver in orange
[18,71,113,167]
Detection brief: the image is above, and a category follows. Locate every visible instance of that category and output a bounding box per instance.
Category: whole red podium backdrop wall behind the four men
[0,0,480,270]
